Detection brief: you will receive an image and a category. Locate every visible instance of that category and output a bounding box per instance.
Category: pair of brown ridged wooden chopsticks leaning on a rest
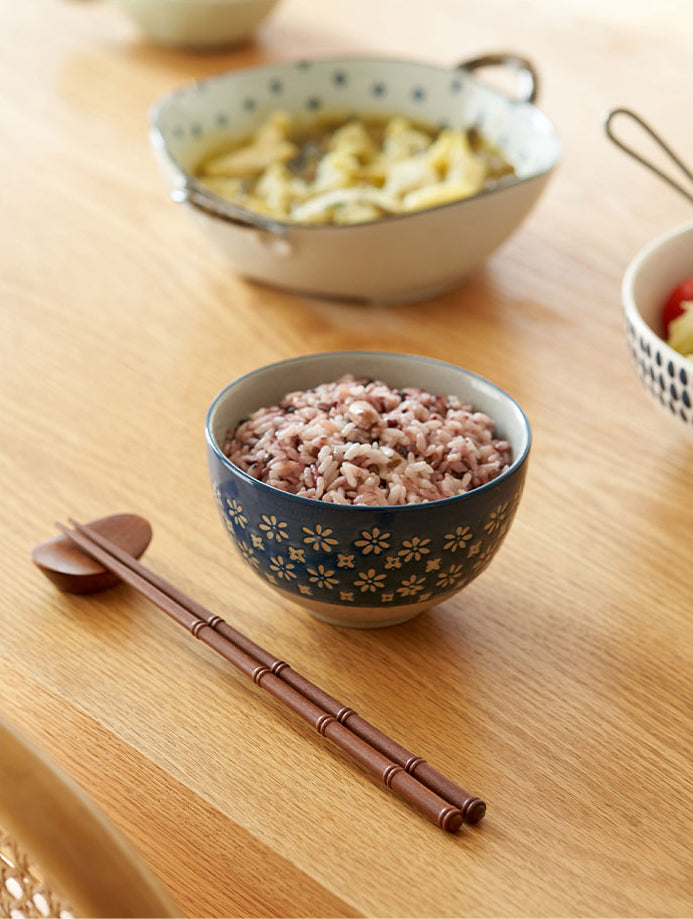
[56,519,486,833]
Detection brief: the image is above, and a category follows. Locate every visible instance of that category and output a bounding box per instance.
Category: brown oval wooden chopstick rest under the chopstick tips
[31,514,152,594]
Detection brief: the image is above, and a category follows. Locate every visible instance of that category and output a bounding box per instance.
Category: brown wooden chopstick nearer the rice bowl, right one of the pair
[69,518,486,823]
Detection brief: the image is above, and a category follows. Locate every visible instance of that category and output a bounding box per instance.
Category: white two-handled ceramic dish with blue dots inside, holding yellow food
[150,54,560,302]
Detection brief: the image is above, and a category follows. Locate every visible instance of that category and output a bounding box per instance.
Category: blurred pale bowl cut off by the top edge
[112,0,279,51]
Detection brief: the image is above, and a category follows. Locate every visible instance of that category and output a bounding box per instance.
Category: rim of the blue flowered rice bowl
[205,351,532,514]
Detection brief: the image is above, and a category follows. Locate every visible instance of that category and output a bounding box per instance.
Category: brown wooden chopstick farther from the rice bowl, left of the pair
[56,520,464,833]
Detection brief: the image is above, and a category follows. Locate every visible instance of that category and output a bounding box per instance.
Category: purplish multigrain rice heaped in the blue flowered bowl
[224,375,512,505]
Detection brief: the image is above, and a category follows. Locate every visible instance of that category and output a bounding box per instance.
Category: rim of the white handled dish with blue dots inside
[149,55,561,234]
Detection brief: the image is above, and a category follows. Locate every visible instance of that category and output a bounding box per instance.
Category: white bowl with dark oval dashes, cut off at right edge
[621,221,693,437]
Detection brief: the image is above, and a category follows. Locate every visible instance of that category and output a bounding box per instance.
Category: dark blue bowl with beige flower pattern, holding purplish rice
[206,352,530,627]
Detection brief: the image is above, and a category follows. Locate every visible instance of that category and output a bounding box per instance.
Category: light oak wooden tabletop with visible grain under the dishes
[0,0,693,916]
